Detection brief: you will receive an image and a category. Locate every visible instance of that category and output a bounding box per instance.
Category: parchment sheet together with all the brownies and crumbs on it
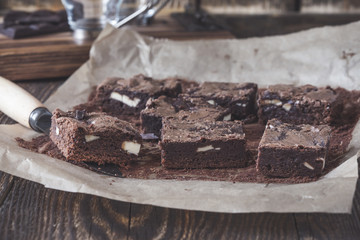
[0,23,360,212]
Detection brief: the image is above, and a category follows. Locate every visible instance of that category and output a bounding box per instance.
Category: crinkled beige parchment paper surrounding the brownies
[0,22,360,213]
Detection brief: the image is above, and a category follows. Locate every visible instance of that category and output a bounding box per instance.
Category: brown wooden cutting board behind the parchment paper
[0,18,234,81]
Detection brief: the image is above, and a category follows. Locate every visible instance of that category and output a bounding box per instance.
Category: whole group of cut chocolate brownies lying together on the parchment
[50,75,343,177]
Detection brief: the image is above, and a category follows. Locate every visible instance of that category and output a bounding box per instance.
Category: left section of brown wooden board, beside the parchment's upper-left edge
[0,32,91,80]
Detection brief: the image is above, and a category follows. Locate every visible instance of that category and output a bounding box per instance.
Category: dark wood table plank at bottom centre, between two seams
[129,203,298,240]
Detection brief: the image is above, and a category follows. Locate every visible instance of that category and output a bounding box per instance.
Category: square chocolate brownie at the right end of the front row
[256,119,330,178]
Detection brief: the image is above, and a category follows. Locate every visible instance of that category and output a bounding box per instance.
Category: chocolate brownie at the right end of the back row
[258,84,342,125]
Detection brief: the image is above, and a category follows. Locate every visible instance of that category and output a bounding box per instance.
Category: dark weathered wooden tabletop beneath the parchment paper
[0,15,360,240]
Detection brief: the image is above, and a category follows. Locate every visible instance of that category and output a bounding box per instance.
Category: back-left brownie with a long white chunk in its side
[93,74,185,116]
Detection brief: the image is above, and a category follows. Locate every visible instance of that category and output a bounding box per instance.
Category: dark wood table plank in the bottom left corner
[0,178,130,239]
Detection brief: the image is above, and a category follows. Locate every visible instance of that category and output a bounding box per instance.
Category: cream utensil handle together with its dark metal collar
[0,77,52,135]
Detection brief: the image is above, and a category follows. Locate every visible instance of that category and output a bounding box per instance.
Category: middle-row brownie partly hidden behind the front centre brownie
[140,96,231,137]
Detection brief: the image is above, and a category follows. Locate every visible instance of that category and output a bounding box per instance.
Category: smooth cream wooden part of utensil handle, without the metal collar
[0,77,44,128]
